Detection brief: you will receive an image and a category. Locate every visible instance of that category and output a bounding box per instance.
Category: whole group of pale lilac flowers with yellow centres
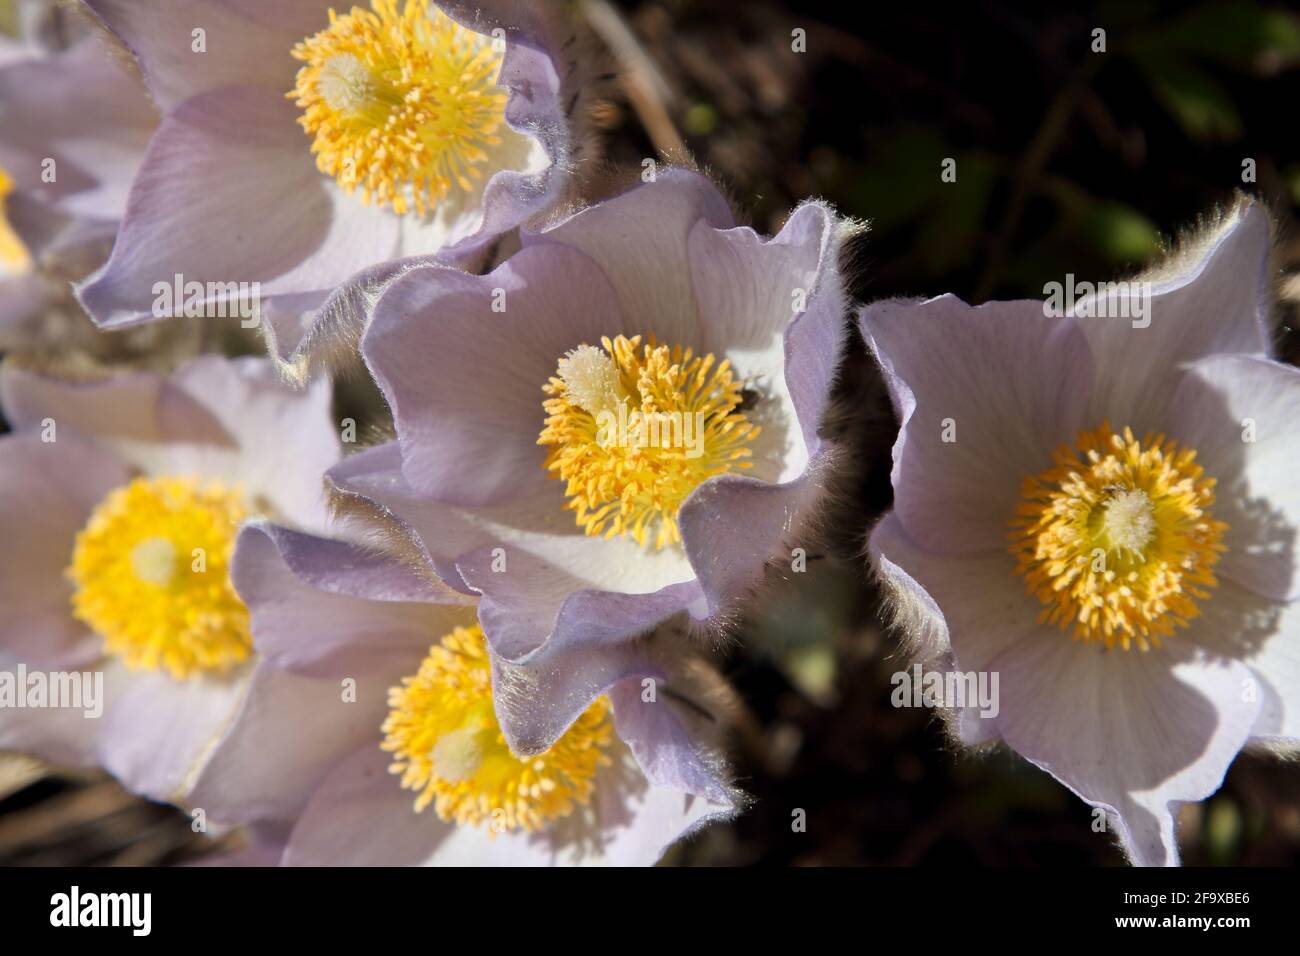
[0,0,1300,864]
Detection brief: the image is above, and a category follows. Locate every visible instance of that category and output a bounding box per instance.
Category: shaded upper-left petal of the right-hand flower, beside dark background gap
[859,295,1093,554]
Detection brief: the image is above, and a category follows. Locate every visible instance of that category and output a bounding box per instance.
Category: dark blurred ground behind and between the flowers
[0,0,1300,865]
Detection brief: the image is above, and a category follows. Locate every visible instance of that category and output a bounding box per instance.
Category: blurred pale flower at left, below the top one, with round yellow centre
[0,356,339,800]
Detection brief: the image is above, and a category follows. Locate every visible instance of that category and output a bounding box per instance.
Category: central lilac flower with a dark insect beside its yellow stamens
[330,169,846,753]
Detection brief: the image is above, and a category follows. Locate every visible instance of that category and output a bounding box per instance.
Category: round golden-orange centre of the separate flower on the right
[1011,423,1227,650]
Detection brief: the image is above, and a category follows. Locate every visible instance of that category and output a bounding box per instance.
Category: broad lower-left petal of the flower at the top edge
[78,87,398,326]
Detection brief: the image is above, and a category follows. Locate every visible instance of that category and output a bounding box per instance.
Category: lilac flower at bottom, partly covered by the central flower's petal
[192,523,736,865]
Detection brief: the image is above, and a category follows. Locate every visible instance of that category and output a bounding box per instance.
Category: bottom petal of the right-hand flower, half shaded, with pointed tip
[987,631,1260,866]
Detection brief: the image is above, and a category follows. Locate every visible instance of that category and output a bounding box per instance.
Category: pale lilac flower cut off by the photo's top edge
[79,0,569,375]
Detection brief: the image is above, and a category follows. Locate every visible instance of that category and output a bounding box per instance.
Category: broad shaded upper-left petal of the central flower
[361,247,634,505]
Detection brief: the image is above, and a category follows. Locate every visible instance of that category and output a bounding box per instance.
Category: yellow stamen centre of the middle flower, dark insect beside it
[537,336,759,549]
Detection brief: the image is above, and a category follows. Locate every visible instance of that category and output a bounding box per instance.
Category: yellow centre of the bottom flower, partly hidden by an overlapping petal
[381,624,614,832]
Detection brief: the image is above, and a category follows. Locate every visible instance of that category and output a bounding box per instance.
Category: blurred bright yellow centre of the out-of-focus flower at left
[66,477,252,680]
